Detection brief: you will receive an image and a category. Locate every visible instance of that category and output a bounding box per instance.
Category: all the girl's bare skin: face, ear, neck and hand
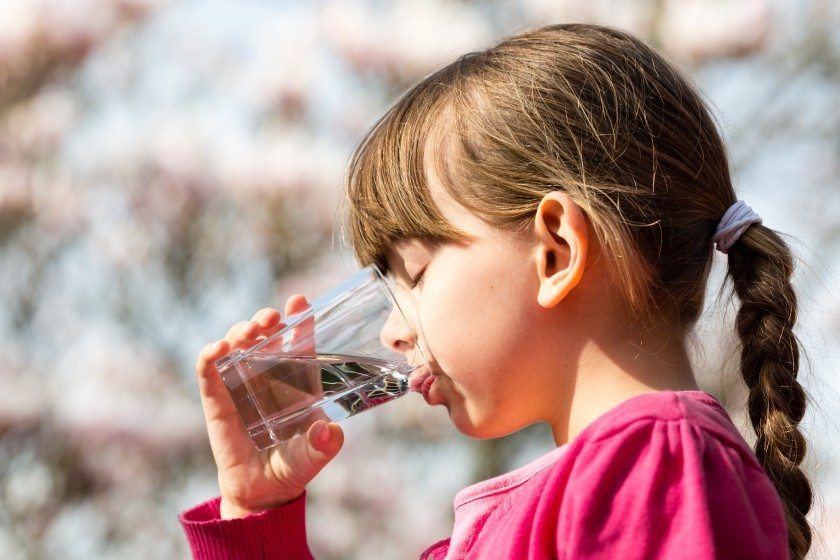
[196,156,697,519]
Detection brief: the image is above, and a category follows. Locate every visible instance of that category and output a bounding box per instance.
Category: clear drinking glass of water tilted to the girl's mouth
[216,266,426,450]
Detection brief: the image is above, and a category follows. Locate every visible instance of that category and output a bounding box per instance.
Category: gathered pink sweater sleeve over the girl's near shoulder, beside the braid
[555,419,788,560]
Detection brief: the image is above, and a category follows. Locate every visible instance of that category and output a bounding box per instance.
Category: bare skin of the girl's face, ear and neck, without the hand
[383,163,697,445]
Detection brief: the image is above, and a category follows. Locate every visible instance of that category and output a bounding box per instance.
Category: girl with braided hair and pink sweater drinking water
[181,25,811,559]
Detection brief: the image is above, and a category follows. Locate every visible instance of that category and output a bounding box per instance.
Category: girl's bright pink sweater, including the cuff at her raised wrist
[180,391,788,560]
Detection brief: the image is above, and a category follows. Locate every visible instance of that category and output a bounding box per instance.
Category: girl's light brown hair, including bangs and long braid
[346,24,811,558]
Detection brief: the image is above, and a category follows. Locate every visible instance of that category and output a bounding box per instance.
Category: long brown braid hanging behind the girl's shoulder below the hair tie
[729,225,812,560]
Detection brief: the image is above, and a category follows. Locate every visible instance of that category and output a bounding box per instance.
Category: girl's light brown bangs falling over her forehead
[344,63,469,272]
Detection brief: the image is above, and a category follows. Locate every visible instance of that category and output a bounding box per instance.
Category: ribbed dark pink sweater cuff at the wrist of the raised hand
[179,493,312,560]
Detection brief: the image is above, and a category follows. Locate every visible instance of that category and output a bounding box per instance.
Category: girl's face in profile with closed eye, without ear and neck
[382,170,568,438]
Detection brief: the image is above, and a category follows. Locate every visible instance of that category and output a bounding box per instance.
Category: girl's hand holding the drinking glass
[196,295,344,519]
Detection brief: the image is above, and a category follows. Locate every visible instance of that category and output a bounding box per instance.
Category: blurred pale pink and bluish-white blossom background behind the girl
[0,0,840,559]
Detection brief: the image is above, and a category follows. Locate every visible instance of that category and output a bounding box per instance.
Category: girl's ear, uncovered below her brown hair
[534,191,589,308]
